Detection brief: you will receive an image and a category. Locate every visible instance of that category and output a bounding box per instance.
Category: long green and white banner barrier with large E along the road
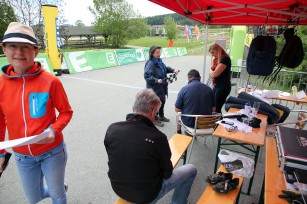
[0,47,187,74]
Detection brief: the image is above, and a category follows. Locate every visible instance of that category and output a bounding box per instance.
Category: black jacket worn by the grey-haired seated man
[104,114,173,203]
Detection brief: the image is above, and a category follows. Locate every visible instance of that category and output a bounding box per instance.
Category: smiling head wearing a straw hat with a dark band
[0,22,39,74]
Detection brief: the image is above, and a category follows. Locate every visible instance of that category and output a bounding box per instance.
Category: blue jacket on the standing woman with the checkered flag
[144,60,175,102]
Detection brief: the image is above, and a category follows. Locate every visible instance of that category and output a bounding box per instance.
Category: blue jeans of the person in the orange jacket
[14,142,67,204]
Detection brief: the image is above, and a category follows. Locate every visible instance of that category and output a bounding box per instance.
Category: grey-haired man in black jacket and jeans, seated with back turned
[104,89,197,204]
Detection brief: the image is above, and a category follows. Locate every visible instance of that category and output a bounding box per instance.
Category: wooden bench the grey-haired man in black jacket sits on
[114,134,192,204]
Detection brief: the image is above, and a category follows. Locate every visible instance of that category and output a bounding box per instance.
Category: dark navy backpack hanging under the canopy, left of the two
[246,36,276,76]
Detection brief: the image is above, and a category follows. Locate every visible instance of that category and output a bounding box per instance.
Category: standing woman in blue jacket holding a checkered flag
[144,45,178,127]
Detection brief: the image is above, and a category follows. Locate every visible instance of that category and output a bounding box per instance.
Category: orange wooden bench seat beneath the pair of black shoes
[197,165,244,204]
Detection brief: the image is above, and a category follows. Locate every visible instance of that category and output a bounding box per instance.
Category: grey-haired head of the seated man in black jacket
[132,89,161,121]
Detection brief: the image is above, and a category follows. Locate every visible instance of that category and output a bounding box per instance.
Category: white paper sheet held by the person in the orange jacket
[0,130,50,150]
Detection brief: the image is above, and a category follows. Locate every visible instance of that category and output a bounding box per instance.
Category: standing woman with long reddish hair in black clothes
[209,44,231,113]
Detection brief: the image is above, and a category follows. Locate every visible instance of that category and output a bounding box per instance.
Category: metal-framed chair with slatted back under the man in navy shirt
[178,113,221,162]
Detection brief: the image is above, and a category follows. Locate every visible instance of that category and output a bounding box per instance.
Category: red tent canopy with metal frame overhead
[149,0,307,25]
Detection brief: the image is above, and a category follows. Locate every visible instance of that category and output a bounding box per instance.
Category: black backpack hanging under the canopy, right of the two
[276,28,304,68]
